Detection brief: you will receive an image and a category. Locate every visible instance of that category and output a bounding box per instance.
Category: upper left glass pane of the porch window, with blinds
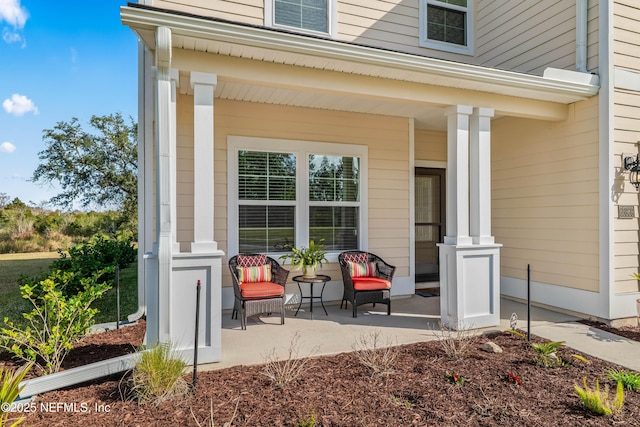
[238,151,296,200]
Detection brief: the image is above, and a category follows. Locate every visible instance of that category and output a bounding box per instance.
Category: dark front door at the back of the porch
[414,168,446,282]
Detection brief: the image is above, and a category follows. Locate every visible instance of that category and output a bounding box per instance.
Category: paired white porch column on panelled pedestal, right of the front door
[438,105,501,329]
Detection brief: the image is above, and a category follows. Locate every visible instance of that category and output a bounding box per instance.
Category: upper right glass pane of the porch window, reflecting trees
[309,154,360,202]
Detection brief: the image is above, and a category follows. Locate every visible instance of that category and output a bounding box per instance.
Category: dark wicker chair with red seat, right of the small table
[338,251,396,317]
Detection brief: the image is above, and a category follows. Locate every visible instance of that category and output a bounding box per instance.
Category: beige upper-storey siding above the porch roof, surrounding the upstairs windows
[146,0,598,75]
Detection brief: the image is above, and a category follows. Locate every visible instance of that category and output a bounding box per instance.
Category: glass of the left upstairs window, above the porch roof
[274,0,328,33]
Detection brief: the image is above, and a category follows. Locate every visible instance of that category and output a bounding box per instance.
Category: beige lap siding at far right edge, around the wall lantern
[613,0,640,293]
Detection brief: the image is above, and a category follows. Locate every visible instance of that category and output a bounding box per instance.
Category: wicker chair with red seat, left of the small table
[229,254,289,330]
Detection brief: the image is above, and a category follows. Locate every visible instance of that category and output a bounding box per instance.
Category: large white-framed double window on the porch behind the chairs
[228,137,367,260]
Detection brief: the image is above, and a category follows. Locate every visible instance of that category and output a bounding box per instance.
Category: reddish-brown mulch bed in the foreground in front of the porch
[5,333,640,427]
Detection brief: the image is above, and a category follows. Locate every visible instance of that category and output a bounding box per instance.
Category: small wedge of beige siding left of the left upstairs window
[152,0,265,25]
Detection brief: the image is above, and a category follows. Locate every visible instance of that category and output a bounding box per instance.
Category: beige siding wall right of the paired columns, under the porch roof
[491,97,599,292]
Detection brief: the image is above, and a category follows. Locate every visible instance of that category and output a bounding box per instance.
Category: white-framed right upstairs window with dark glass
[420,0,473,55]
